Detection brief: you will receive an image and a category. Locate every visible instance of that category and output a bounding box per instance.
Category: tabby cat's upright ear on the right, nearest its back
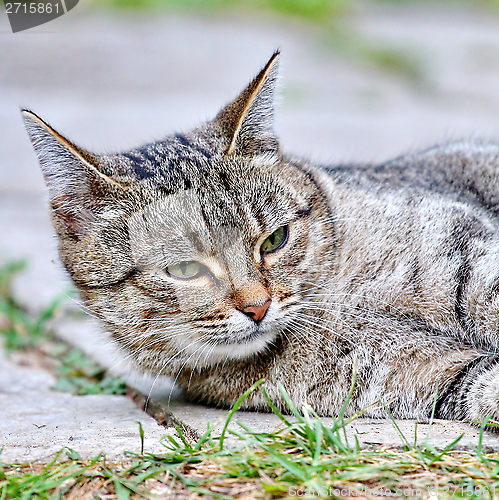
[215,51,279,156]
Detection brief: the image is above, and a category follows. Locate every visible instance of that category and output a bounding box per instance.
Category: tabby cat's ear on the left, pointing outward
[22,110,123,236]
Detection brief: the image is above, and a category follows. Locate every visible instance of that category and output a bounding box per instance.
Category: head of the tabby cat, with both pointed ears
[23,53,332,372]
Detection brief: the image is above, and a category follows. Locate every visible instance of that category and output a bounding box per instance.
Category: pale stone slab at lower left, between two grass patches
[0,351,173,463]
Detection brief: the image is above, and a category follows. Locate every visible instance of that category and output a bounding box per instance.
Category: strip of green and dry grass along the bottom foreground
[0,384,499,499]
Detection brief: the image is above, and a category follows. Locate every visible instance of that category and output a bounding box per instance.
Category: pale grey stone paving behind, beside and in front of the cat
[0,2,499,461]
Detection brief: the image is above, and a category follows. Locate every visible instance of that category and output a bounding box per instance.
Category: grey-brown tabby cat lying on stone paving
[22,52,499,422]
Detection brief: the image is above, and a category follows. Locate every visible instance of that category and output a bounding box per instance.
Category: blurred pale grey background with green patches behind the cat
[0,0,499,386]
